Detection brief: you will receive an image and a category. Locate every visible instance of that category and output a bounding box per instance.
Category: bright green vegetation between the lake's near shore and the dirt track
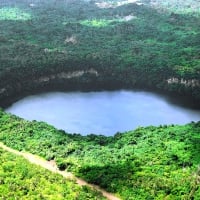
[0,112,200,200]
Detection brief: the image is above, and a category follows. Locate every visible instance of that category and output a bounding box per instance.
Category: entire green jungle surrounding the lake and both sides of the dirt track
[0,0,200,200]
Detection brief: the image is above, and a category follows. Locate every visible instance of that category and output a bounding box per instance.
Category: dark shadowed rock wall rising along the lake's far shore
[0,67,200,107]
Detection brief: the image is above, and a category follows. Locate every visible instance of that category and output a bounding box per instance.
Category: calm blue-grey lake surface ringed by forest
[6,90,200,136]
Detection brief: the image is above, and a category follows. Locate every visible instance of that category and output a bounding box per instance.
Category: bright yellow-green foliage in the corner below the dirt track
[0,148,104,200]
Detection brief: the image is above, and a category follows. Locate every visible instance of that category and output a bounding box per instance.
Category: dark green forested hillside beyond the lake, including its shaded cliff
[0,0,200,105]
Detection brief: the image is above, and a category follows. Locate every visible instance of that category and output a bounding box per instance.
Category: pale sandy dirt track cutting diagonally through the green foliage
[0,142,120,200]
